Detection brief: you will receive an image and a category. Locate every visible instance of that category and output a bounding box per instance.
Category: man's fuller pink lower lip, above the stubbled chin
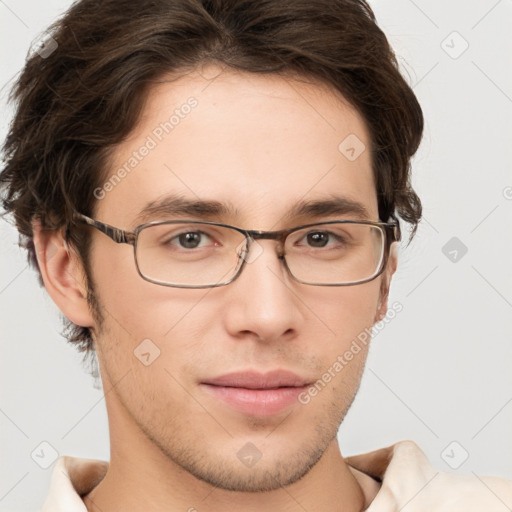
[202,384,307,416]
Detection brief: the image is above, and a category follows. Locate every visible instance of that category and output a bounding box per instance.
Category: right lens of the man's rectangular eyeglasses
[285,223,385,284]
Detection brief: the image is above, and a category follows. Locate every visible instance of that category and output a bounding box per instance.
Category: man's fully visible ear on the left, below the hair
[32,221,94,327]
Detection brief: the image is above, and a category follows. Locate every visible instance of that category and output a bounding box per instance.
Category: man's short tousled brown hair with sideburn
[0,0,423,355]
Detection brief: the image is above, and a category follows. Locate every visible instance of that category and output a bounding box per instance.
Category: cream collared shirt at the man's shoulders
[41,441,512,512]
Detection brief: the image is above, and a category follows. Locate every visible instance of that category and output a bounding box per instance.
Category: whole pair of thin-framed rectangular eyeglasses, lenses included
[75,213,401,288]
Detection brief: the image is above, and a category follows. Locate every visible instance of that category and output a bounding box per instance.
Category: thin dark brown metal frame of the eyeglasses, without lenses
[74,212,401,288]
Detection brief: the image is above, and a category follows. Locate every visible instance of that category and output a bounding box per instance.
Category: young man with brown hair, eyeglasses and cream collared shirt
[1,0,512,512]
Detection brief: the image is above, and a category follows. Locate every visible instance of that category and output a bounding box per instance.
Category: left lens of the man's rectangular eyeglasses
[136,223,245,286]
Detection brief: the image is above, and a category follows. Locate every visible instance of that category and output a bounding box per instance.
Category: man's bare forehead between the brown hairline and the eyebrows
[96,65,377,229]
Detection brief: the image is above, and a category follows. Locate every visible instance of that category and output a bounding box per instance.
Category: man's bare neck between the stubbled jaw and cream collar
[84,426,366,512]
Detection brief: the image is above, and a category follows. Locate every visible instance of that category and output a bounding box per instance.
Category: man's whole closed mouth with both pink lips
[201,370,311,416]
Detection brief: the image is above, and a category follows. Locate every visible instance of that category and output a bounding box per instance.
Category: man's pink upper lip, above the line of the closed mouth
[203,370,309,389]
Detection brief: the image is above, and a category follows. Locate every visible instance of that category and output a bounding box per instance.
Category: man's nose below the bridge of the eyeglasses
[224,240,306,342]
